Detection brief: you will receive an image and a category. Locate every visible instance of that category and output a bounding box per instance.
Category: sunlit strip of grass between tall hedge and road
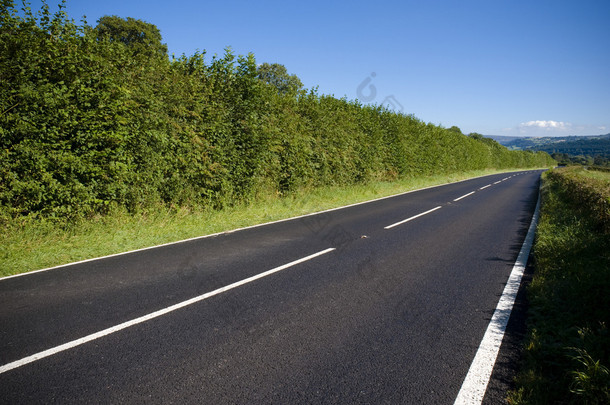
[0,170,528,276]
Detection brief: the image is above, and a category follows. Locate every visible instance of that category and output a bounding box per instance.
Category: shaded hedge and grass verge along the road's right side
[509,167,610,404]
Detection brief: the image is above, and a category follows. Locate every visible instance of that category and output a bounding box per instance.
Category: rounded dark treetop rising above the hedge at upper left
[95,15,167,56]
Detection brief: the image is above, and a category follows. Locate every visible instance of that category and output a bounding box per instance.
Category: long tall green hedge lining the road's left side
[0,0,552,219]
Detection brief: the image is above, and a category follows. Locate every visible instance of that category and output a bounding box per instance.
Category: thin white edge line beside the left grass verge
[0,172,524,281]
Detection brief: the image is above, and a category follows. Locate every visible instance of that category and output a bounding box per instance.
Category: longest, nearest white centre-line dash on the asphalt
[0,248,335,374]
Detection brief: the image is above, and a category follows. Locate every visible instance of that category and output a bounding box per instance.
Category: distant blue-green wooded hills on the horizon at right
[488,134,610,165]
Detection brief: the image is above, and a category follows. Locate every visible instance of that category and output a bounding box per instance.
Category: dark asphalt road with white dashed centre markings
[0,171,540,404]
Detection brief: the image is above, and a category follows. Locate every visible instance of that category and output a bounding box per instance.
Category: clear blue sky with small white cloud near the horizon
[26,0,610,136]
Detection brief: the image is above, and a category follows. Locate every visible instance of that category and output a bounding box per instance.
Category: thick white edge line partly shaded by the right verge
[454,187,540,405]
